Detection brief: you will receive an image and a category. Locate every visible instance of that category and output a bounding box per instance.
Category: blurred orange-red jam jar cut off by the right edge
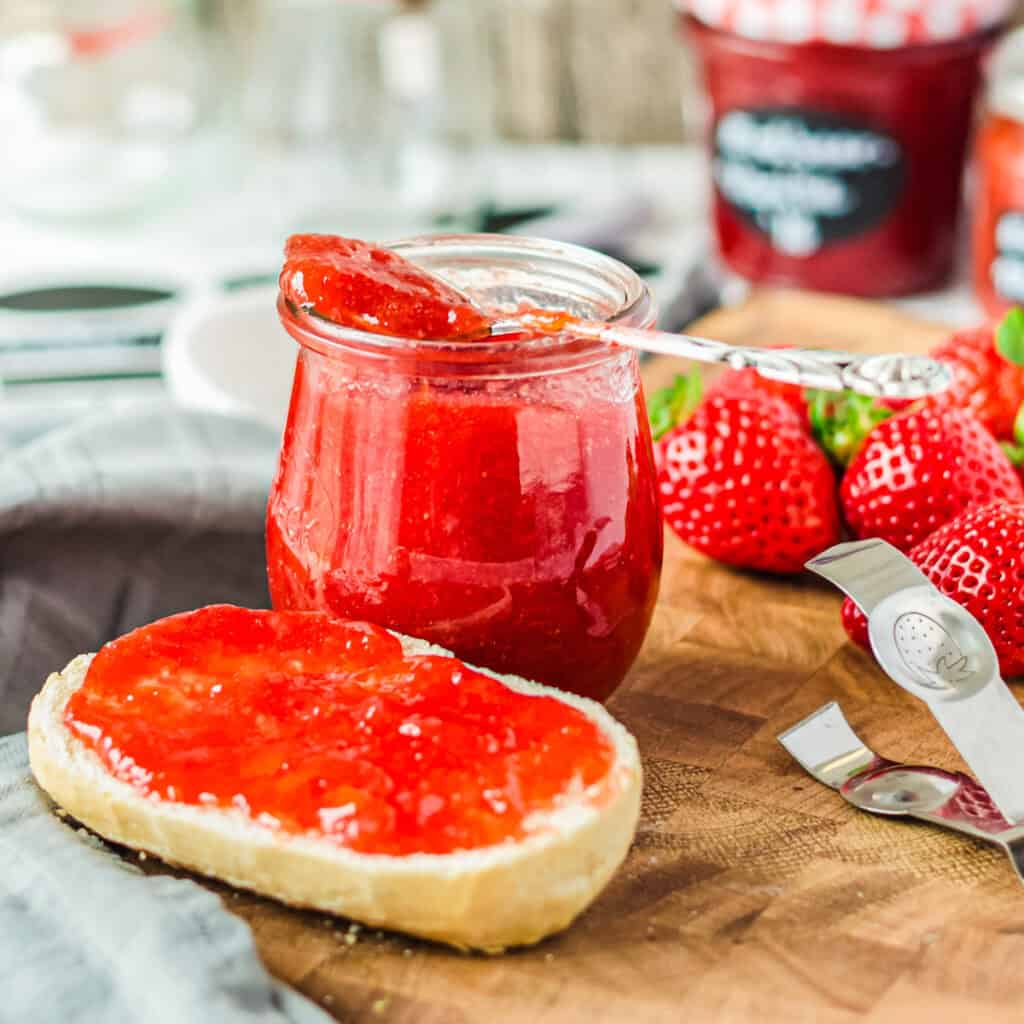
[972,29,1024,317]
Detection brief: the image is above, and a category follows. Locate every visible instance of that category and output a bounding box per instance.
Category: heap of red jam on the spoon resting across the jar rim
[281,234,490,340]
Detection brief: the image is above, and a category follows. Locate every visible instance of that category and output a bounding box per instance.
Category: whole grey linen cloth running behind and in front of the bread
[0,406,329,1024]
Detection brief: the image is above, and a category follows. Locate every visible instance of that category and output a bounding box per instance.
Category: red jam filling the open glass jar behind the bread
[267,351,662,699]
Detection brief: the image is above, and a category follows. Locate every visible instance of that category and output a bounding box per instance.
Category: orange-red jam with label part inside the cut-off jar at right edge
[973,114,1024,316]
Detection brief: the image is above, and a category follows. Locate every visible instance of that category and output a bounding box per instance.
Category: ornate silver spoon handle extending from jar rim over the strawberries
[494,321,951,398]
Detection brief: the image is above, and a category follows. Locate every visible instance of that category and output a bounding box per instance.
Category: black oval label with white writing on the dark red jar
[714,106,905,256]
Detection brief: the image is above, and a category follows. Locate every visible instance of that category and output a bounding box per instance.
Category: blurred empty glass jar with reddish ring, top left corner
[0,0,215,219]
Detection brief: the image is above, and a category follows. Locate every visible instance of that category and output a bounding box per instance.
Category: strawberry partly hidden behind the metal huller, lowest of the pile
[843,502,1024,677]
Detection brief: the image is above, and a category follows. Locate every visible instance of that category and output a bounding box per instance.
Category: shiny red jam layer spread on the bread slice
[65,605,614,855]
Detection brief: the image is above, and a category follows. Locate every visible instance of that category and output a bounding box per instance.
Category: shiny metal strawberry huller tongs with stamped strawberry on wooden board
[778,541,1024,882]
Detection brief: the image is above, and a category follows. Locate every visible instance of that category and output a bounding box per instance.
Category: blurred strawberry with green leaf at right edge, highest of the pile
[928,309,1024,440]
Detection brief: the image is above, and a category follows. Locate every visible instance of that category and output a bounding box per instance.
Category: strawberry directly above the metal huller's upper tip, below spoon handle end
[840,404,1024,551]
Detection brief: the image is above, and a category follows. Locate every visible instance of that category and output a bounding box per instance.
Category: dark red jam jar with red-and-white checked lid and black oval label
[683,0,1012,296]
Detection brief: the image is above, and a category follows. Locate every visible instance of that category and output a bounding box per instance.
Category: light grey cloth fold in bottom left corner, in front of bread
[0,733,330,1024]
